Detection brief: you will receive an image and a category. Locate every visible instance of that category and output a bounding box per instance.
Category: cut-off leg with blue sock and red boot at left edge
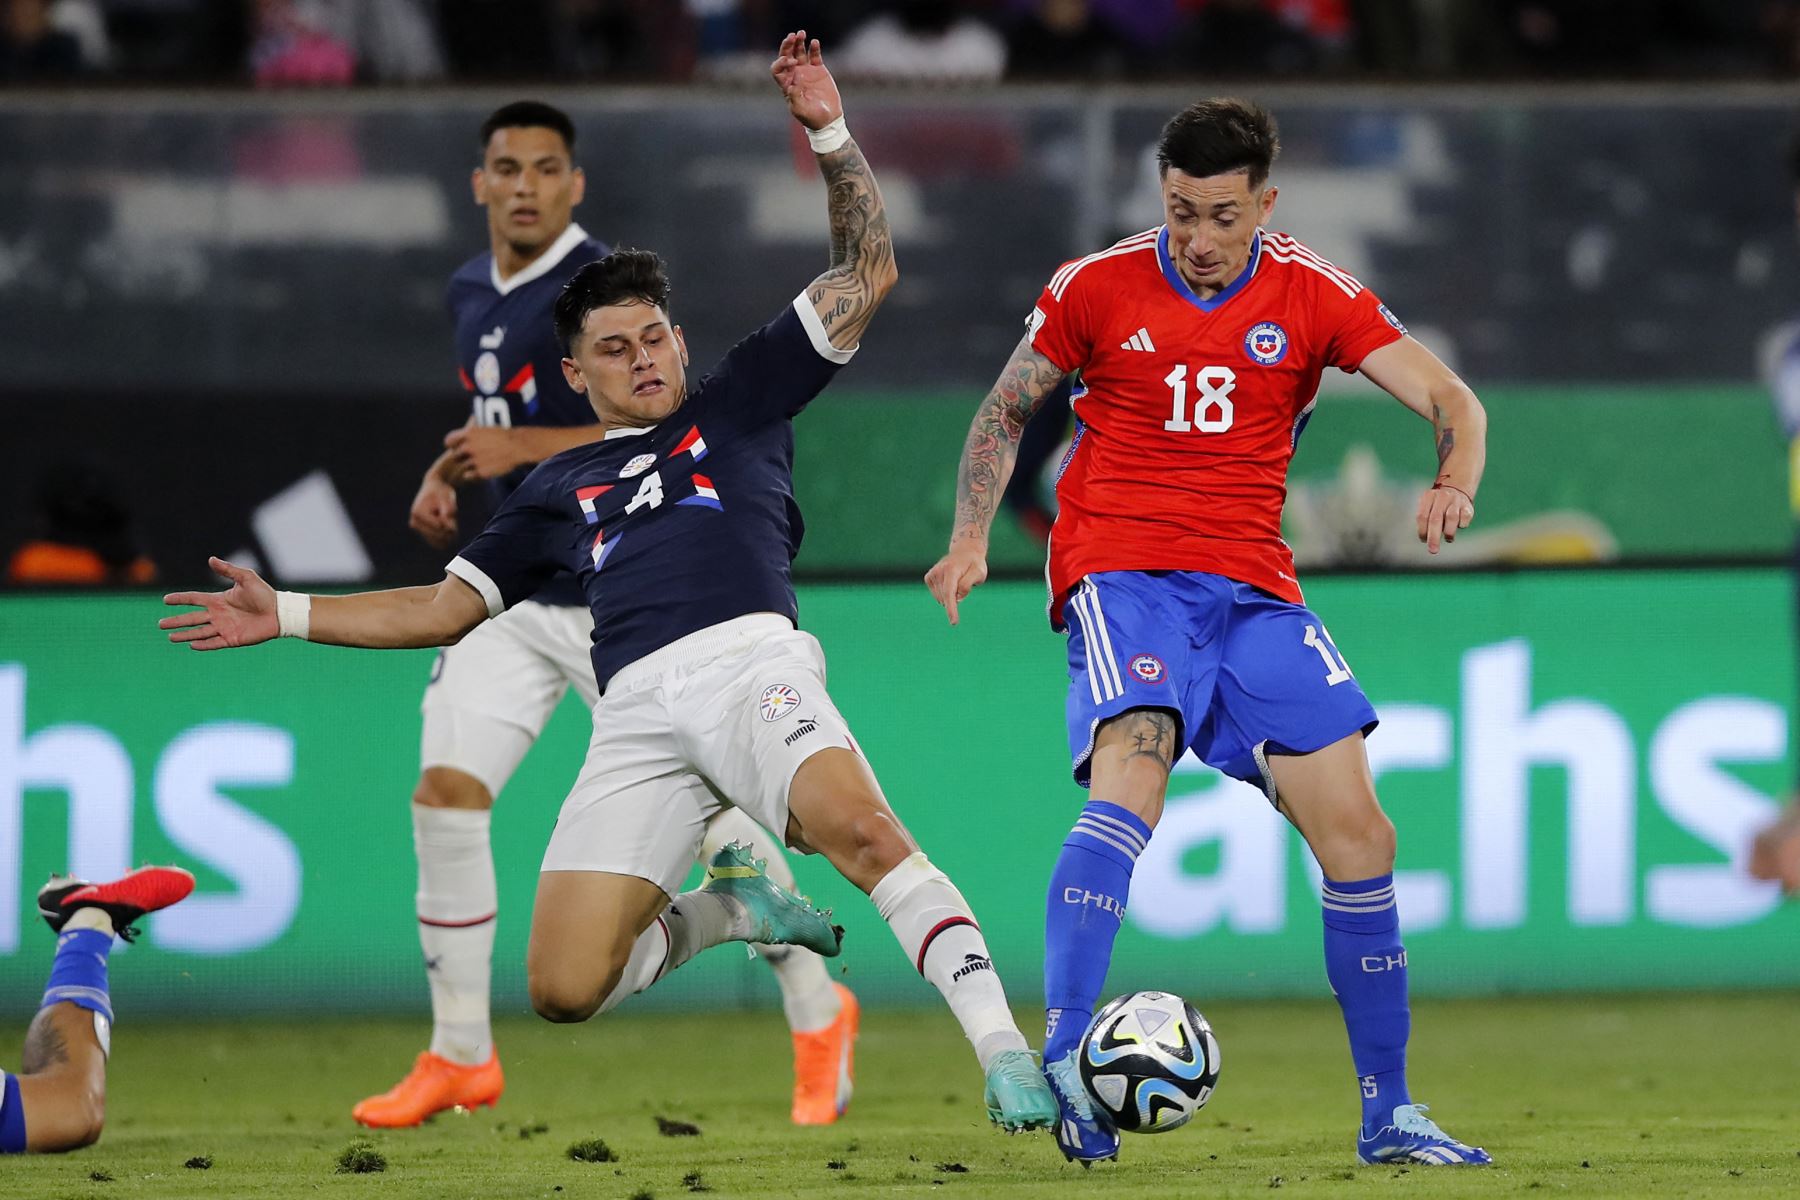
[0,867,194,1155]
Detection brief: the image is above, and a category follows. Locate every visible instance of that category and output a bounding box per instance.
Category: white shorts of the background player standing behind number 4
[419,601,599,797]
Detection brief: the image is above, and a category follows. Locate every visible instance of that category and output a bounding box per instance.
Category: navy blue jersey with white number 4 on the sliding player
[448,293,851,689]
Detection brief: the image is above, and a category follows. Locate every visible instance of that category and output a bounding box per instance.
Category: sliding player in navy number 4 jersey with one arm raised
[162,32,1057,1130]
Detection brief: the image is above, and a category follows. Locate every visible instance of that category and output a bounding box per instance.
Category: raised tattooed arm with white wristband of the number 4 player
[769,29,900,351]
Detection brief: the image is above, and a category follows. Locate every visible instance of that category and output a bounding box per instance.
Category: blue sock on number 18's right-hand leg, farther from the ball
[1323,874,1413,1128]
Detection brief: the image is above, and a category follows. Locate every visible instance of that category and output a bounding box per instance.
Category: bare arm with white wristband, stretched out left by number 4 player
[157,558,488,649]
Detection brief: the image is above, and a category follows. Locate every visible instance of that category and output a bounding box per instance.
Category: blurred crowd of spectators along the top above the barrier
[10,0,1800,86]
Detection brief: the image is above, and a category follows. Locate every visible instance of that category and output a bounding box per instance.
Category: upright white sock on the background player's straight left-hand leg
[412,804,499,1067]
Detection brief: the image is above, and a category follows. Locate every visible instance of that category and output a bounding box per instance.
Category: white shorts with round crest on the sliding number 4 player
[544,613,857,896]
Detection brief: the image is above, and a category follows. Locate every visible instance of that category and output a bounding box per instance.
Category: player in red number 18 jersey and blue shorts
[925,101,1489,1164]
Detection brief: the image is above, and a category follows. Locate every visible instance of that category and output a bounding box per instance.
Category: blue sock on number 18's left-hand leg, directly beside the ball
[1044,801,1150,1061]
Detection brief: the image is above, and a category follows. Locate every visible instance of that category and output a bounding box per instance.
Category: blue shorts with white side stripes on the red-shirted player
[1062,570,1377,801]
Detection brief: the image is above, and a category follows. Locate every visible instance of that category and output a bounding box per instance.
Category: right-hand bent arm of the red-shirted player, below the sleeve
[1357,335,1487,554]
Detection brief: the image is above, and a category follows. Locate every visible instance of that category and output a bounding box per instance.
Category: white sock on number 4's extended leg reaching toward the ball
[869,851,1026,1070]
